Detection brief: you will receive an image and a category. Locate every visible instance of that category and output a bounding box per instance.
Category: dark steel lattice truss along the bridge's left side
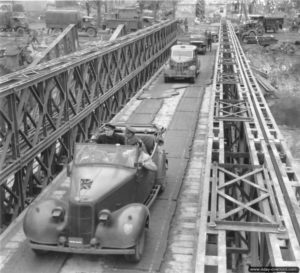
[0,21,177,227]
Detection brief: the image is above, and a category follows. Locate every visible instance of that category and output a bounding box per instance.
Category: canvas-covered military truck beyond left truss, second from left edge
[45,10,97,36]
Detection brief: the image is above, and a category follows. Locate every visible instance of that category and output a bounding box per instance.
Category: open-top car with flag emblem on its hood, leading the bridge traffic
[24,125,167,262]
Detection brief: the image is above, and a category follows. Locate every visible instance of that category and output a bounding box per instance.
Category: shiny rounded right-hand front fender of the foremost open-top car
[95,203,150,248]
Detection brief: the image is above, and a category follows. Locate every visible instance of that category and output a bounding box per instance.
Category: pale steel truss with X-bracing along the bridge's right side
[195,21,300,273]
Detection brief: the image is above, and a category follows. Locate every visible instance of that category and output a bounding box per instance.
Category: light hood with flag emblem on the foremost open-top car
[71,165,136,202]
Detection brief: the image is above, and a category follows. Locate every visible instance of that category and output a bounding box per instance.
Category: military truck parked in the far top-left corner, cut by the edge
[0,11,29,35]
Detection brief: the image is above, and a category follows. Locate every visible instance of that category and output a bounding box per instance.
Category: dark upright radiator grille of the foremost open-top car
[69,204,94,244]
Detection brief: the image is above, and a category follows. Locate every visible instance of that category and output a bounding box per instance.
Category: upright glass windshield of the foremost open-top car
[74,143,137,168]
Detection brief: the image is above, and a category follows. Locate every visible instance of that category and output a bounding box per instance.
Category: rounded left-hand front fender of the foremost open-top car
[23,199,67,244]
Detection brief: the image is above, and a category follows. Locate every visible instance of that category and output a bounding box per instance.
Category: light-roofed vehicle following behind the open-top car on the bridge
[164,44,200,83]
